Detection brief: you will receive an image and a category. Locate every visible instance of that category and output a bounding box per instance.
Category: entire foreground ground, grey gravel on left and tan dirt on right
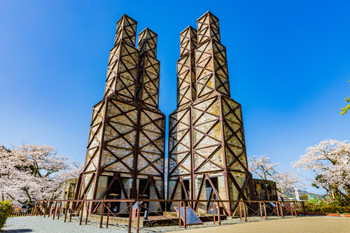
[3,216,350,233]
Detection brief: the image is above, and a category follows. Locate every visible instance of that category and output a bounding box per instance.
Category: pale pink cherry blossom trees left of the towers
[0,145,82,204]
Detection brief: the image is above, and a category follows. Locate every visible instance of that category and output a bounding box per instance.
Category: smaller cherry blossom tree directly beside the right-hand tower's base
[249,155,301,197]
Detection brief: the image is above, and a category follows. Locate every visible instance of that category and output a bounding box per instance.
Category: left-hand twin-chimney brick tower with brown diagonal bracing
[75,15,165,214]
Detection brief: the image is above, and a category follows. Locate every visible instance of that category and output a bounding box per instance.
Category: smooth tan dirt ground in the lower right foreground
[171,216,350,233]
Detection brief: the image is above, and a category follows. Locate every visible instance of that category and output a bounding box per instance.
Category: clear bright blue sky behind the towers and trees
[0,0,350,191]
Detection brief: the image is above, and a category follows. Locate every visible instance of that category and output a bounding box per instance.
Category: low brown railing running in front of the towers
[31,199,305,232]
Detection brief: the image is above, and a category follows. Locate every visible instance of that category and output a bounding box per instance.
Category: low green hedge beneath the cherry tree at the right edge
[305,202,350,213]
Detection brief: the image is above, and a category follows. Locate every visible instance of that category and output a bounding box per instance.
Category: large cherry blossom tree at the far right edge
[293,139,350,204]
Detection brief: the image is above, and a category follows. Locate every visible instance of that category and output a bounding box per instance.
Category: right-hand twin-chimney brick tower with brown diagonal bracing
[168,12,255,214]
